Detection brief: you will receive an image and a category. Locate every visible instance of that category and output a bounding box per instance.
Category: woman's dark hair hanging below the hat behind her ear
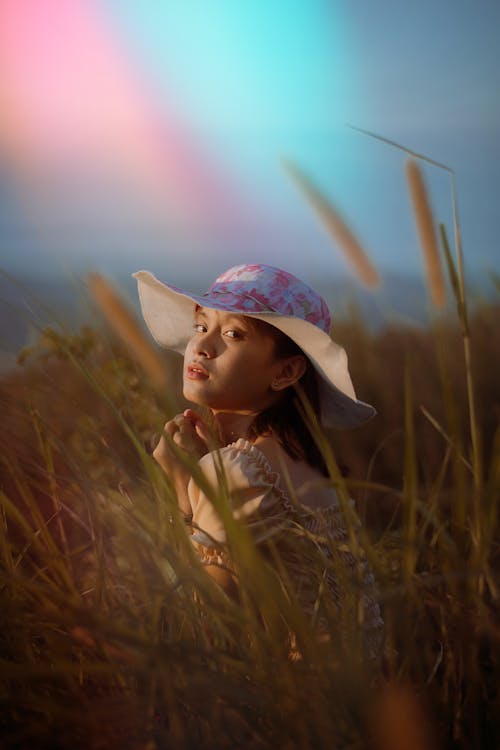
[247,317,328,476]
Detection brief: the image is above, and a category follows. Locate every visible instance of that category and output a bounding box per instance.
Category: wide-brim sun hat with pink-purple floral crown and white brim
[133,264,376,427]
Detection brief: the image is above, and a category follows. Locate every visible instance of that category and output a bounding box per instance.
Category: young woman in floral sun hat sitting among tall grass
[134,264,382,654]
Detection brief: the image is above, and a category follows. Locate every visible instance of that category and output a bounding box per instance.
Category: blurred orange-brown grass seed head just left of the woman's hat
[88,273,166,389]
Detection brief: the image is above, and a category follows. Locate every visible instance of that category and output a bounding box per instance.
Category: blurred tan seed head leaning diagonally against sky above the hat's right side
[282,159,380,287]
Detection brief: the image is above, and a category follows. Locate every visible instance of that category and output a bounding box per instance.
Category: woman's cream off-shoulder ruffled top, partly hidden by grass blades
[188,438,383,656]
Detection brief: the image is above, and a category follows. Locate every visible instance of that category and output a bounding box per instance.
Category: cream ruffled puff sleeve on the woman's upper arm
[188,439,286,546]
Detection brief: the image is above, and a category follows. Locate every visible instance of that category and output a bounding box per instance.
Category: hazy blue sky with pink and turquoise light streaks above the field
[0,0,500,362]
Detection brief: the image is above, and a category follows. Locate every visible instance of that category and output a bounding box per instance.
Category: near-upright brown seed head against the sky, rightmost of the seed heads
[406,159,446,308]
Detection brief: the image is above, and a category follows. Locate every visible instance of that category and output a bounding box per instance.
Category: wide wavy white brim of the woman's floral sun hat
[133,271,376,427]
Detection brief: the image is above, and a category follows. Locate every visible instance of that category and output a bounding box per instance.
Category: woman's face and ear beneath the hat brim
[183,307,283,414]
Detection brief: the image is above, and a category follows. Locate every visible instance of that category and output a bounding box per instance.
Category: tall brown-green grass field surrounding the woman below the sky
[0,292,500,749]
